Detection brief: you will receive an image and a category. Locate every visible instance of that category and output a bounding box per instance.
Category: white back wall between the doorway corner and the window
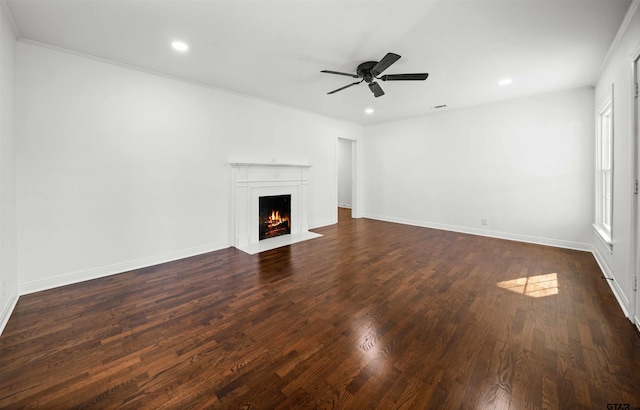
[363,87,594,249]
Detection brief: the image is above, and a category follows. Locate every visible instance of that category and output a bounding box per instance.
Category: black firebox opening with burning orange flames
[258,195,291,240]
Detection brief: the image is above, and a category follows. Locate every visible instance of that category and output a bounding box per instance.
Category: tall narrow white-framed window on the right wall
[594,94,613,246]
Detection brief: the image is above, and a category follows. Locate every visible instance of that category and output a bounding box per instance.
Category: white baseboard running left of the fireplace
[19,244,229,295]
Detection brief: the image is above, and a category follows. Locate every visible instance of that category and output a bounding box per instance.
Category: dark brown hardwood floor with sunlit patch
[0,210,640,409]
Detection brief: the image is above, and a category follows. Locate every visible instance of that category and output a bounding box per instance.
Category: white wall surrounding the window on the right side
[592,2,640,316]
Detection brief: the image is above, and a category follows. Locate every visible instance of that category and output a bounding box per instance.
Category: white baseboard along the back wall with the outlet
[364,214,593,252]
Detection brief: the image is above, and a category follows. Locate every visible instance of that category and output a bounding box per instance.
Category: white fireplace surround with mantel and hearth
[229,162,322,255]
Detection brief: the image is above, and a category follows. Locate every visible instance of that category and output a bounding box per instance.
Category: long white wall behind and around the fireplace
[16,42,362,293]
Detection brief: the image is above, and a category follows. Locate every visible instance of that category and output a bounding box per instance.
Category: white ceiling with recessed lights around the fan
[7,0,631,124]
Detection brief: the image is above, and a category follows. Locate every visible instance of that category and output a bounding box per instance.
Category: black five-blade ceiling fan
[321,53,429,97]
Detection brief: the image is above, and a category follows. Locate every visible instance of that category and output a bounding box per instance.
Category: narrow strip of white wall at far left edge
[0,2,18,333]
